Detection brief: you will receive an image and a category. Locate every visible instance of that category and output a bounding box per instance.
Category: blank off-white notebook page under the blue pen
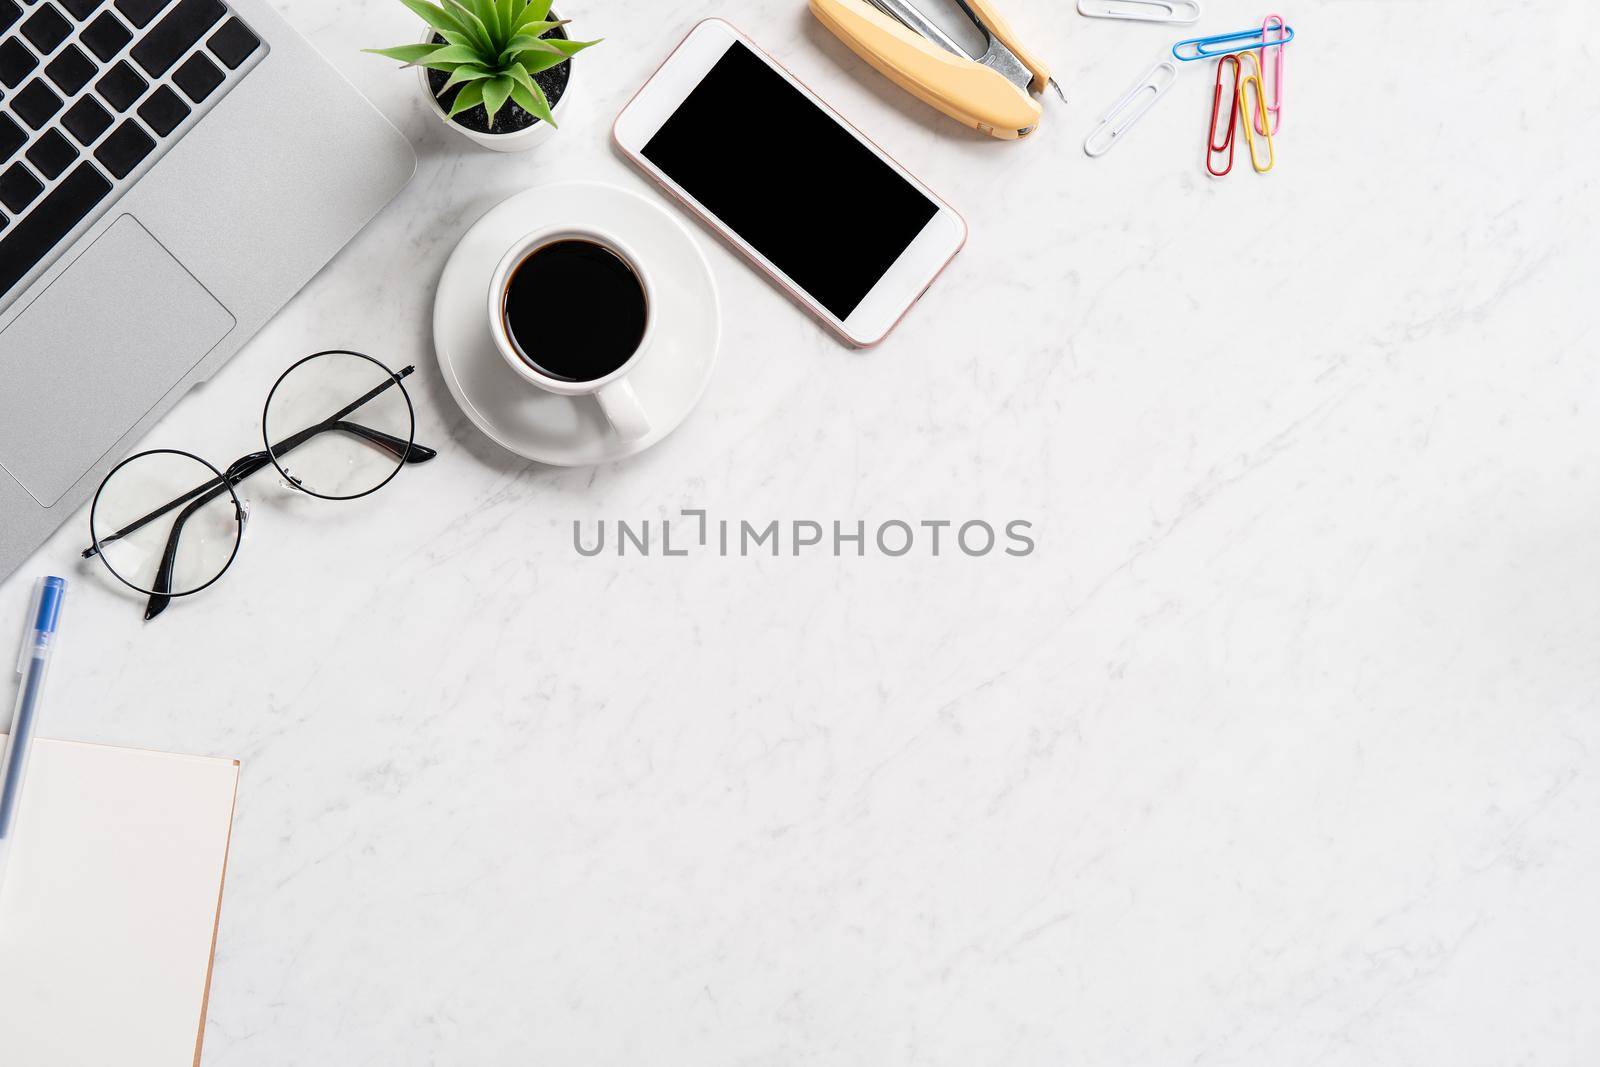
[0,739,238,1067]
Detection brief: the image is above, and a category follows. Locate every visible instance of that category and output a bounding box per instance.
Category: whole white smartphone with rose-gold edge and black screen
[611,19,966,347]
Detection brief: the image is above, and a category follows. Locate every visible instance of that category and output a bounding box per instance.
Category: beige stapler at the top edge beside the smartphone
[811,0,1066,141]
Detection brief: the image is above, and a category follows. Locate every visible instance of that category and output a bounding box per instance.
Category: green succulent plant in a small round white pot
[366,0,598,152]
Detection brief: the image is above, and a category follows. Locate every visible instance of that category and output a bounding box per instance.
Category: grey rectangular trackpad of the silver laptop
[0,214,234,507]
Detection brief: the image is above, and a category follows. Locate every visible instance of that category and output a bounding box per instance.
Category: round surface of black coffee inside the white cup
[501,237,650,382]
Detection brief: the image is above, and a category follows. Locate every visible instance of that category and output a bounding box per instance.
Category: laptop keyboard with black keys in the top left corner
[0,0,266,302]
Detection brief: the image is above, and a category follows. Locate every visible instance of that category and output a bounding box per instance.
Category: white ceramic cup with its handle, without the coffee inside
[488,226,656,442]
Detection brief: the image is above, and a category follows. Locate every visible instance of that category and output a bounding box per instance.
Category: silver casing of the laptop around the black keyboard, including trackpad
[0,0,416,579]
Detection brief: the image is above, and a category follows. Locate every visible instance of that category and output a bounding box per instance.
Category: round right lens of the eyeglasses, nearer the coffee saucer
[261,352,416,501]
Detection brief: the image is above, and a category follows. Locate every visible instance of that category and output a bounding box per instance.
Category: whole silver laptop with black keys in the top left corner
[0,0,416,577]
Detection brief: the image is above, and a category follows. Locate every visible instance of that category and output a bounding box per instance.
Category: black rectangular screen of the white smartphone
[645,42,939,320]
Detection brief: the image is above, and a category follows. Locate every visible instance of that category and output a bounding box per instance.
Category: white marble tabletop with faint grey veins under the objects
[0,0,1600,1067]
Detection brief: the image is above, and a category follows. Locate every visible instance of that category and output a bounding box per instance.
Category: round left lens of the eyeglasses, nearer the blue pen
[90,450,245,597]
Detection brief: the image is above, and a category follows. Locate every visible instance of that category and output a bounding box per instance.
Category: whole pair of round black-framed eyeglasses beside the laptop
[83,349,438,619]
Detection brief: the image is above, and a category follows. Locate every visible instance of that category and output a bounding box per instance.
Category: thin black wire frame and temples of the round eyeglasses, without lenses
[82,349,438,621]
